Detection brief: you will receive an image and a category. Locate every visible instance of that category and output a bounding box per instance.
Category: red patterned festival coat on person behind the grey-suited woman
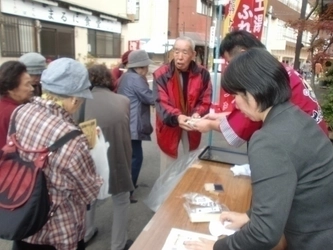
[220,66,328,147]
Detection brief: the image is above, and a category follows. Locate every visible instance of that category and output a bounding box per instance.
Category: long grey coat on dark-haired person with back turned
[85,87,134,195]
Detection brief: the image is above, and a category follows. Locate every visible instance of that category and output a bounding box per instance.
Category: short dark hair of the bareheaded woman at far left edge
[0,61,27,96]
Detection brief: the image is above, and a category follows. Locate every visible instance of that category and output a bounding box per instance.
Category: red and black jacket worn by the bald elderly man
[153,61,212,158]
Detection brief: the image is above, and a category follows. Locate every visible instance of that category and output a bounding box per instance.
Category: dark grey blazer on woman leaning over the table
[214,102,333,250]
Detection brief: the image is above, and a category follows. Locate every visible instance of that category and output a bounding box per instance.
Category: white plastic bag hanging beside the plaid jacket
[90,127,111,200]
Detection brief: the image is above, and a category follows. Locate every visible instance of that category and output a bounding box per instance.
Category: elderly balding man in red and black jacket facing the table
[153,37,212,174]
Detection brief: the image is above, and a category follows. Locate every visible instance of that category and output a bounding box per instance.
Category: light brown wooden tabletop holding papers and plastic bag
[130,161,252,250]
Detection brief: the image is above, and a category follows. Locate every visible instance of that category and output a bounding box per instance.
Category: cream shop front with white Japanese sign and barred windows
[0,0,131,65]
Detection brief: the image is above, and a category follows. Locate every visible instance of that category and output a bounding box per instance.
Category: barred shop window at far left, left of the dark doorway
[0,15,36,57]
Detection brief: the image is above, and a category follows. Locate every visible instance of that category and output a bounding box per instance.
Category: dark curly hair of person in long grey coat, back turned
[88,64,112,88]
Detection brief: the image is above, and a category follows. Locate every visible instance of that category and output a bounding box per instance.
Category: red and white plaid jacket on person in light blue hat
[11,97,102,250]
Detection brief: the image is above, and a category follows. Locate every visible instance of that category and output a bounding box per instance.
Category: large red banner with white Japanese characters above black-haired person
[231,0,266,39]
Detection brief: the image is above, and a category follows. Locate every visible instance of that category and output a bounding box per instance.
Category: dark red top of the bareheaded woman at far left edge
[0,97,20,149]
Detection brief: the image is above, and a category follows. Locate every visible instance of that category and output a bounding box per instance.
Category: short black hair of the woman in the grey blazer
[221,48,291,111]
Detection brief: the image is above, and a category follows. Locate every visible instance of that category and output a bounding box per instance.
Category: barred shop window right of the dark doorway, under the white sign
[88,30,121,58]
